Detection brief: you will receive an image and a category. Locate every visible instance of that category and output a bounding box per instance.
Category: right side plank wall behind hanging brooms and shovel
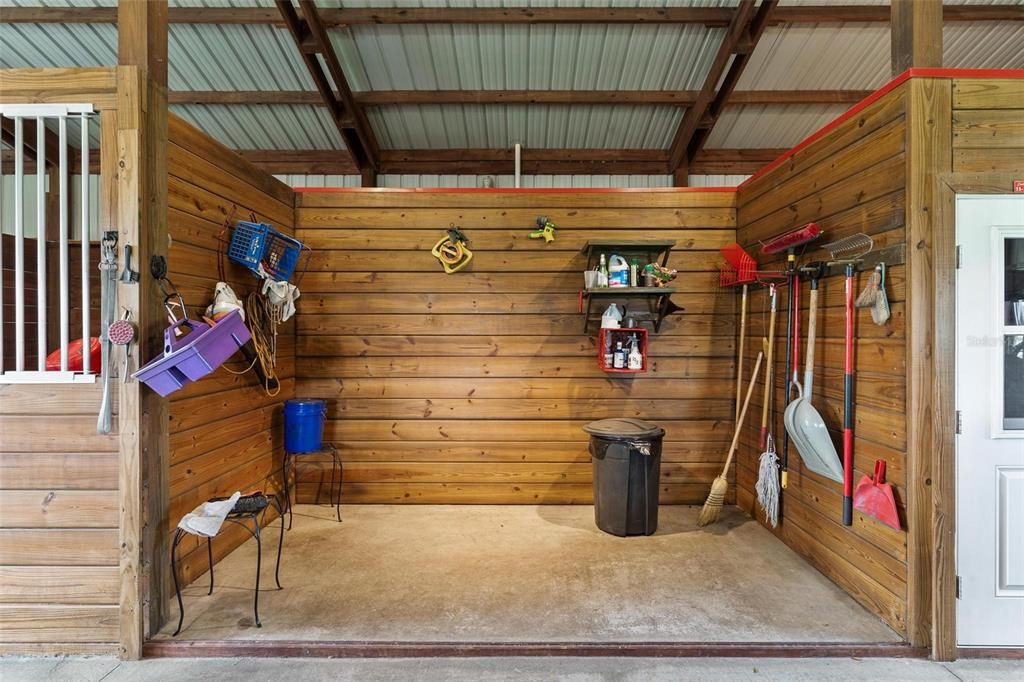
[736,86,907,635]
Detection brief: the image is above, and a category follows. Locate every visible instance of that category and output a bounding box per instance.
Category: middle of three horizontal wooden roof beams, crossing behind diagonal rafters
[168,90,872,108]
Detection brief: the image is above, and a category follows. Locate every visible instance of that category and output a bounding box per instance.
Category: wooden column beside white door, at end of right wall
[898,75,952,646]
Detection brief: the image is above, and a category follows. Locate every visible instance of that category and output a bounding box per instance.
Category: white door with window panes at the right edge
[956,195,1024,646]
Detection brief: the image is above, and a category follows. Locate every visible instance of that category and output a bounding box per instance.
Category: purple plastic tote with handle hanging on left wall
[132,310,252,396]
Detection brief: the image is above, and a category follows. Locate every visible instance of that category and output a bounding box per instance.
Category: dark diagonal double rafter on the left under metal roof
[276,0,378,172]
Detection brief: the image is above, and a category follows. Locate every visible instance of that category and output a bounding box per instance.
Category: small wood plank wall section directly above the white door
[952,78,1024,174]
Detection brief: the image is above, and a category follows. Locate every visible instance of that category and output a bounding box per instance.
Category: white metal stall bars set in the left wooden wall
[0,104,95,383]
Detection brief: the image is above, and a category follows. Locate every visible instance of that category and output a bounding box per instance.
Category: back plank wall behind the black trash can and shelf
[297,191,735,504]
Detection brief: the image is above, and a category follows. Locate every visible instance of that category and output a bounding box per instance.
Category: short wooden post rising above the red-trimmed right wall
[890,0,942,76]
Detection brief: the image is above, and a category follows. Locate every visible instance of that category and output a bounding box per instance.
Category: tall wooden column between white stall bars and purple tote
[118,0,170,658]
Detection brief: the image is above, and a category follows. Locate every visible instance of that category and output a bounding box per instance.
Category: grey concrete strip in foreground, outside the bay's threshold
[0,658,1024,682]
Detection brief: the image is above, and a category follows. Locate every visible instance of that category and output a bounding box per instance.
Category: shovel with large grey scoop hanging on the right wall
[783,269,843,483]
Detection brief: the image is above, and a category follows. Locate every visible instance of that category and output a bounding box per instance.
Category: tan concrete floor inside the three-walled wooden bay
[160,505,899,642]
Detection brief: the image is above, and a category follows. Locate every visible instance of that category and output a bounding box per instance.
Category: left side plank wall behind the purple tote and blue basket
[168,116,295,584]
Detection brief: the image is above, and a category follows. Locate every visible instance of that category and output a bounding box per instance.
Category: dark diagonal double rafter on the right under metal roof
[669,0,778,180]
